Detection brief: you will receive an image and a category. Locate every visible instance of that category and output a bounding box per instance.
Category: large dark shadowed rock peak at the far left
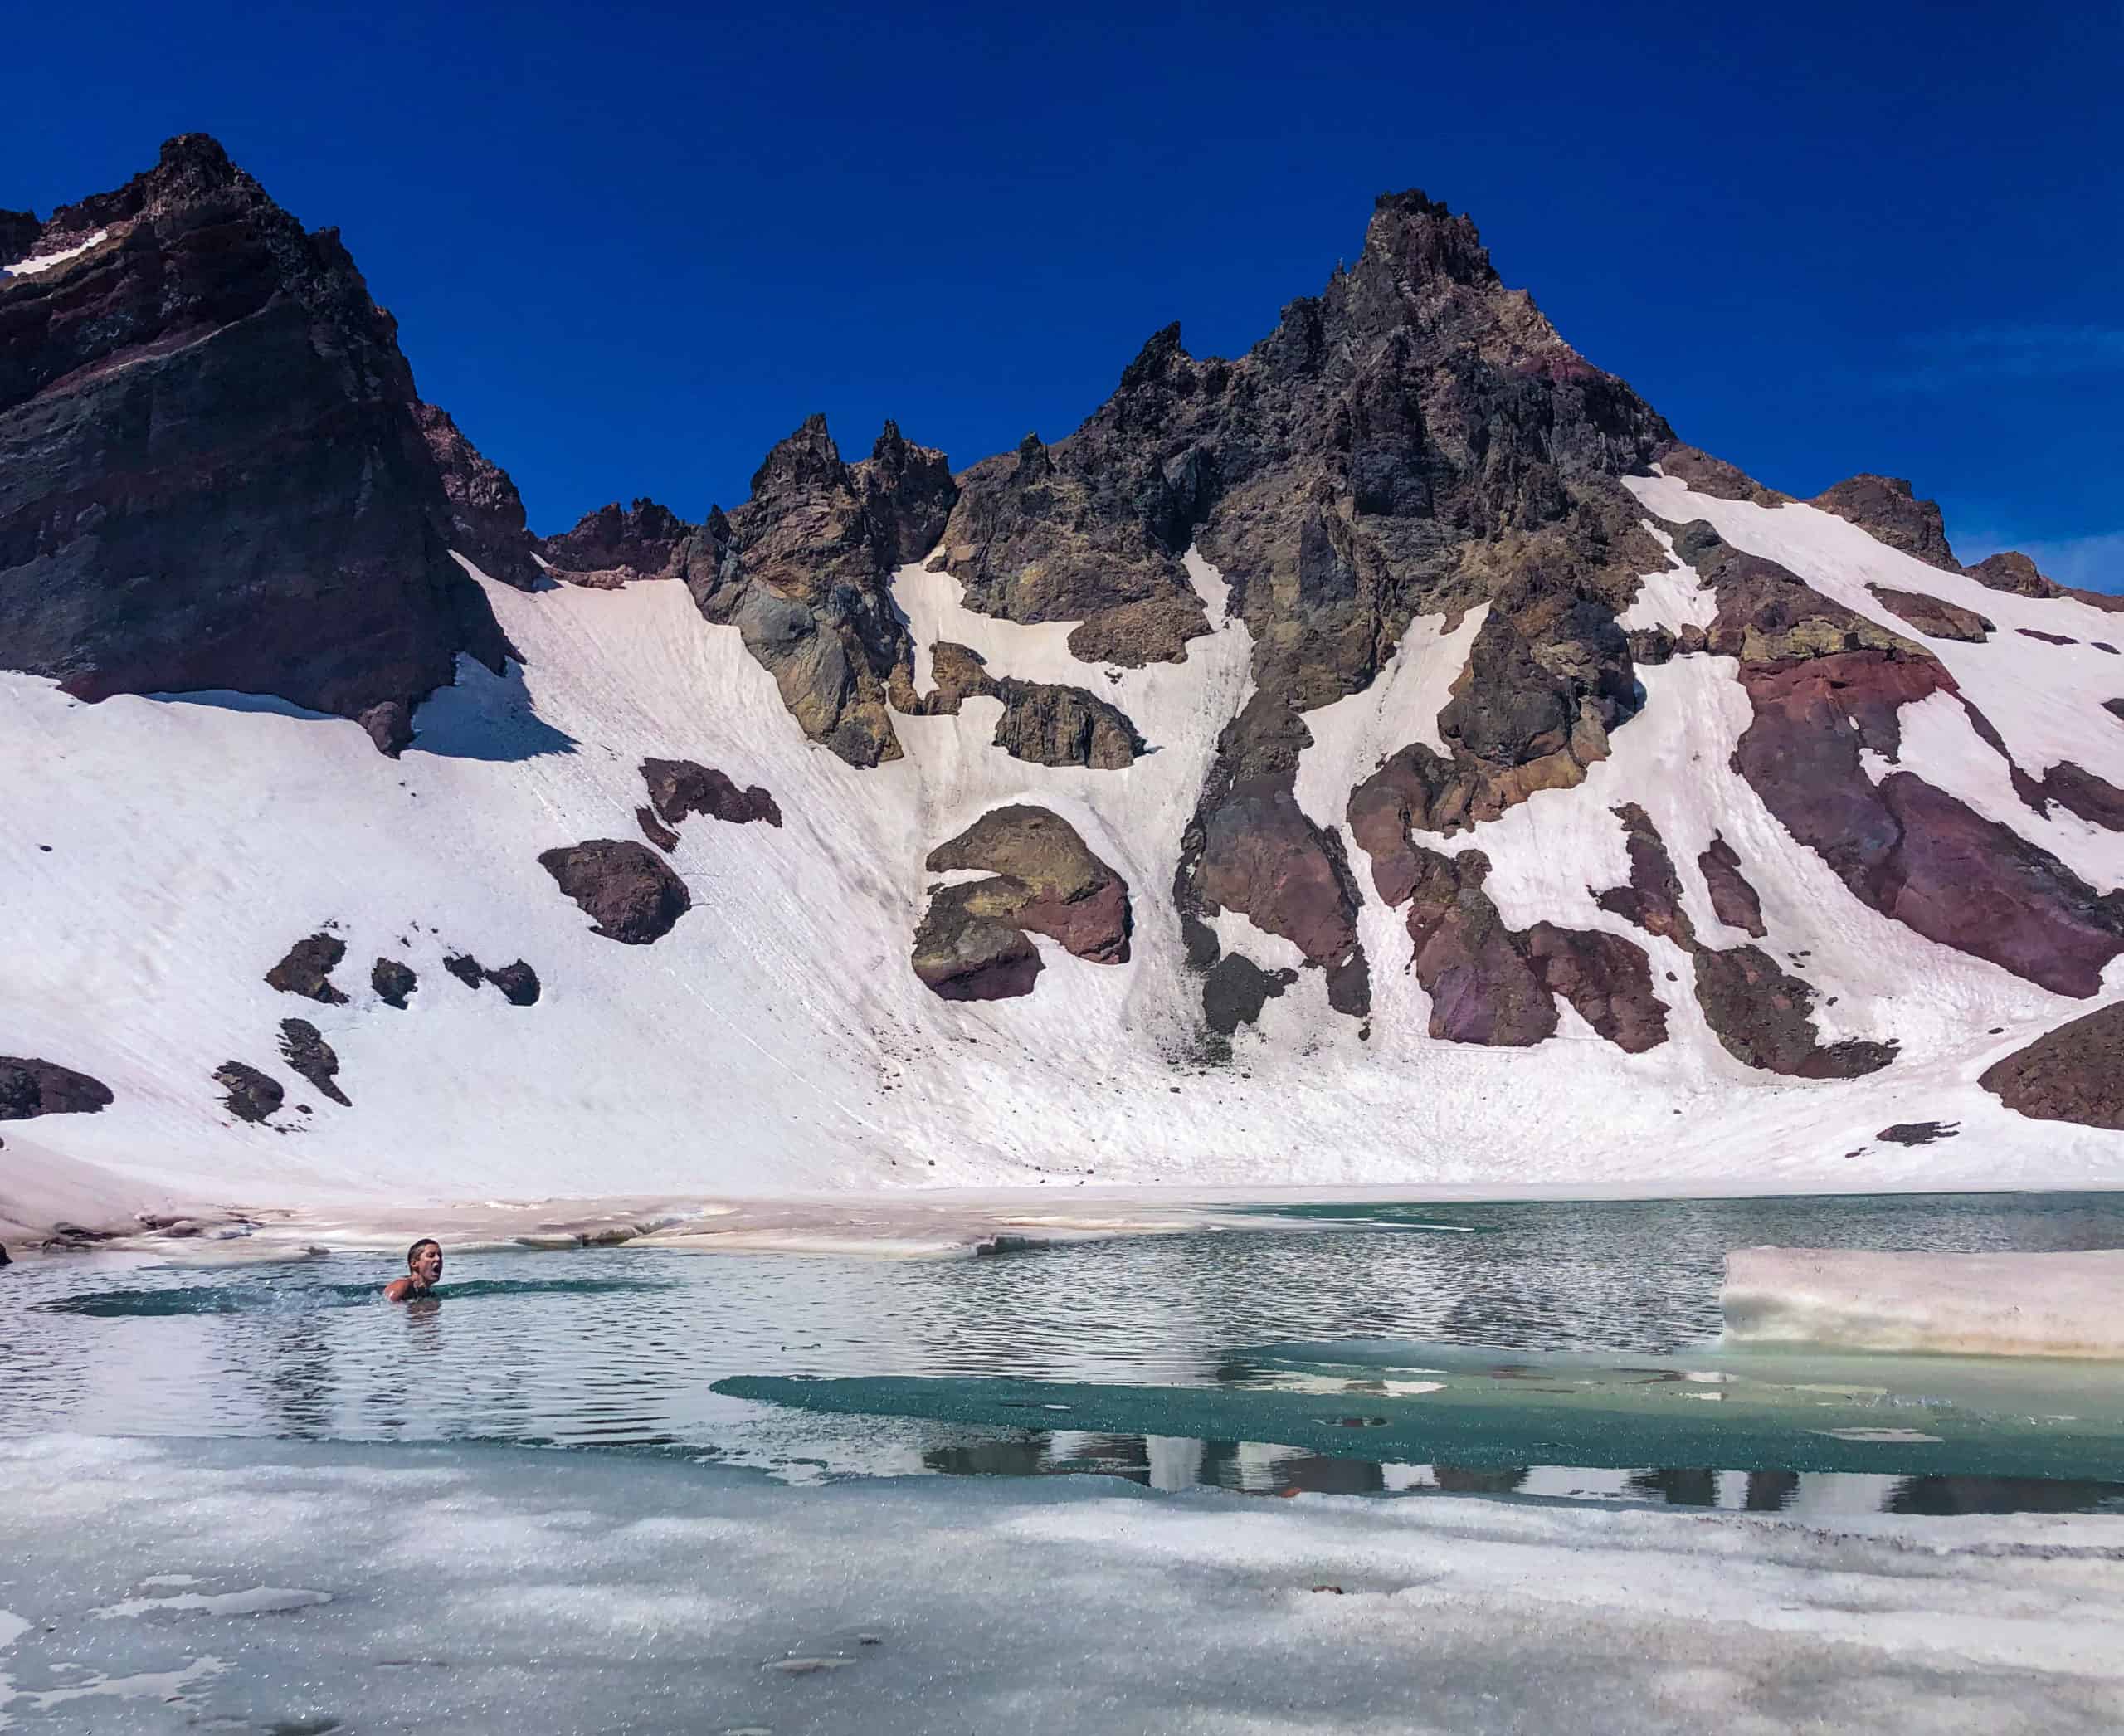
[0,134,508,739]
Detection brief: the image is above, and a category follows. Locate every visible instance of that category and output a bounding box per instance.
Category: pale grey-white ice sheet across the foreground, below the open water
[0,1436,2124,1736]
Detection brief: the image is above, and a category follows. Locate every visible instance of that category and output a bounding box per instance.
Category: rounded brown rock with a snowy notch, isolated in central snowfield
[913,805,1134,1001]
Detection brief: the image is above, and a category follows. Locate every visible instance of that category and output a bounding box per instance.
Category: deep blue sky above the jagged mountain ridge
[0,0,2124,588]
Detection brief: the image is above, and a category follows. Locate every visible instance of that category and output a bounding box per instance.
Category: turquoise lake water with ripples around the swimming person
[0,1194,2124,1511]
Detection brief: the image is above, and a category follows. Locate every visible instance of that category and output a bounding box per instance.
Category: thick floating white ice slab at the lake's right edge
[1718,1247,2124,1358]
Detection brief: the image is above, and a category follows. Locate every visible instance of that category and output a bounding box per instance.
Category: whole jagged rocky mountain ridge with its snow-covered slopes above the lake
[0,138,2124,1222]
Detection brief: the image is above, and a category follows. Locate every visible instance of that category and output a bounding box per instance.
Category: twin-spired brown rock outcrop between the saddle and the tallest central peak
[678,417,958,765]
